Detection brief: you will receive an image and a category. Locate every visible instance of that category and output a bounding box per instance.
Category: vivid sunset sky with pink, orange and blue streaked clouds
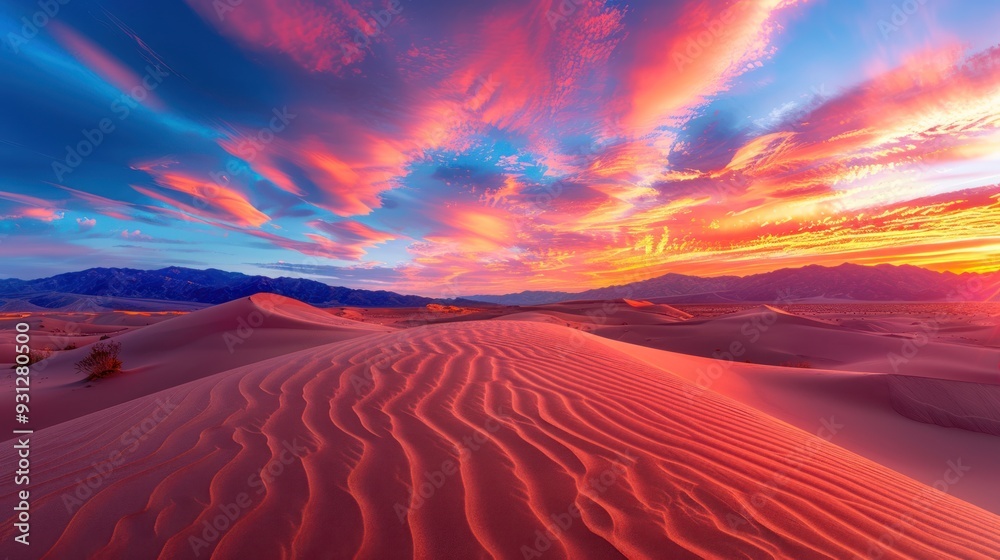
[0,0,1000,297]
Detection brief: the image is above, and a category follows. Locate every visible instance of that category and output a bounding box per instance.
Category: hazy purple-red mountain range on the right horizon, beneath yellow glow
[467,264,1000,305]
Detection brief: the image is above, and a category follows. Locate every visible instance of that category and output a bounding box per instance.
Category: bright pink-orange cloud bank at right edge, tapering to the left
[726,43,1000,213]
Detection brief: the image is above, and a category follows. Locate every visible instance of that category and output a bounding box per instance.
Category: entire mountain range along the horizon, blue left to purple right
[0,264,1000,311]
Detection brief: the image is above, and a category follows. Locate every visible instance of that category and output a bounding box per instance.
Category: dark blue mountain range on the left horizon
[0,267,480,311]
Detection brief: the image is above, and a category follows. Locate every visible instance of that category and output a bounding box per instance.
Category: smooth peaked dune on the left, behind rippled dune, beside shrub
[0,294,392,427]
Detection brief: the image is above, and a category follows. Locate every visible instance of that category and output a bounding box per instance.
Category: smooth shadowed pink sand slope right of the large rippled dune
[599,339,1000,514]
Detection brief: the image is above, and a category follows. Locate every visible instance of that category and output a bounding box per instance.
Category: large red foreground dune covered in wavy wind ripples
[0,321,1000,560]
